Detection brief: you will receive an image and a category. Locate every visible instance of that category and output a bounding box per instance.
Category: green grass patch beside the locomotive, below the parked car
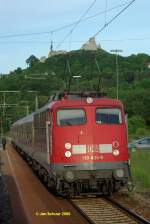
[130,150,150,189]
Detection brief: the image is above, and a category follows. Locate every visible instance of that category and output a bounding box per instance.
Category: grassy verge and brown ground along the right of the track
[114,149,150,221]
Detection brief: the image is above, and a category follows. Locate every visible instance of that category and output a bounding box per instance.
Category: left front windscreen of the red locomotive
[57,109,86,126]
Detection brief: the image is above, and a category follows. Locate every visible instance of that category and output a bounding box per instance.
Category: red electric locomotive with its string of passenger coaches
[11,92,130,197]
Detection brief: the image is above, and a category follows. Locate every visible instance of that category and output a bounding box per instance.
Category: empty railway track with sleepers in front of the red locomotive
[70,198,150,224]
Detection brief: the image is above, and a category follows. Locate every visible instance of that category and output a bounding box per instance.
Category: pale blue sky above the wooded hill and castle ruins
[0,0,150,73]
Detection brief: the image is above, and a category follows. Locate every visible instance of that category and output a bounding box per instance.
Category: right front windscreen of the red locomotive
[96,108,122,124]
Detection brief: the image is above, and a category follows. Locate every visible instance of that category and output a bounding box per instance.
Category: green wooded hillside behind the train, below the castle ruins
[0,49,150,137]
